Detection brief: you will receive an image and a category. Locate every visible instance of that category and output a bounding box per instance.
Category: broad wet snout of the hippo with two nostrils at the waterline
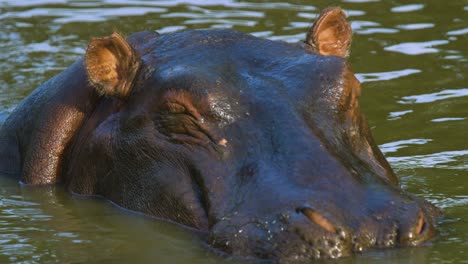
[209,180,438,263]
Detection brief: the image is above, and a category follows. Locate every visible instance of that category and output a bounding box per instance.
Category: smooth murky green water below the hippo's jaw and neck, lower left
[0,178,227,263]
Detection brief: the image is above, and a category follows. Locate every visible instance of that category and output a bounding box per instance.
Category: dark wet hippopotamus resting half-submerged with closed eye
[0,8,439,263]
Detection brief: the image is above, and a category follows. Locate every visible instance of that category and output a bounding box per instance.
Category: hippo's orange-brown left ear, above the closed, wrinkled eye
[85,33,140,98]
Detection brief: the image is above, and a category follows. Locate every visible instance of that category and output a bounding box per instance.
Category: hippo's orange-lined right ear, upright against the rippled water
[305,7,352,57]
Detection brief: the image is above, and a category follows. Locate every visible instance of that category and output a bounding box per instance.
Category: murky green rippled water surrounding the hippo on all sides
[0,0,468,263]
